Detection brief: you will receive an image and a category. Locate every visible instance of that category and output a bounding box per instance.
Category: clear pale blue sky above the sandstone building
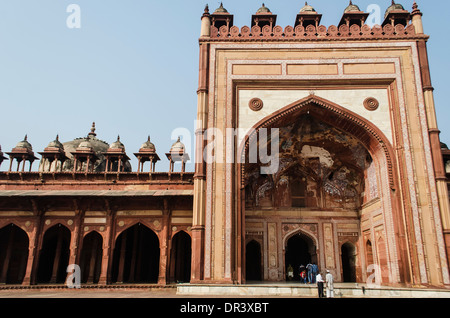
[0,0,450,171]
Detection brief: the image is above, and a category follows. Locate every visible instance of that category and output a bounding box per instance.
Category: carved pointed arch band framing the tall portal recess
[236,95,409,281]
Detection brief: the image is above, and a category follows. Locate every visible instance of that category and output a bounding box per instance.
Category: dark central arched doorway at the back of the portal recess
[284,232,317,281]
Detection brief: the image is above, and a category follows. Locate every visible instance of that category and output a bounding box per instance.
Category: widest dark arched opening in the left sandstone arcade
[112,223,160,283]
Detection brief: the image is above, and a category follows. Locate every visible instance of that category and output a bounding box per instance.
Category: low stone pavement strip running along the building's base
[0,283,450,299]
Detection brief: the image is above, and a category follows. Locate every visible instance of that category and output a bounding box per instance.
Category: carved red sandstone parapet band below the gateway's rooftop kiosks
[209,24,423,41]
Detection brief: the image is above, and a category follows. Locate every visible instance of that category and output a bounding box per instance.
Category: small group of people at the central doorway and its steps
[288,263,334,298]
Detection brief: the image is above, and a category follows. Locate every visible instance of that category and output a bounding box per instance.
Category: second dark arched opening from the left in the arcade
[37,224,71,284]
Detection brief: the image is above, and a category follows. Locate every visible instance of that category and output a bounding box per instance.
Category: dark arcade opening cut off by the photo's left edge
[0,224,29,284]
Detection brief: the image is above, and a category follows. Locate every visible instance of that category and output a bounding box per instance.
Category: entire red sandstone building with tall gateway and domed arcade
[0,2,450,288]
